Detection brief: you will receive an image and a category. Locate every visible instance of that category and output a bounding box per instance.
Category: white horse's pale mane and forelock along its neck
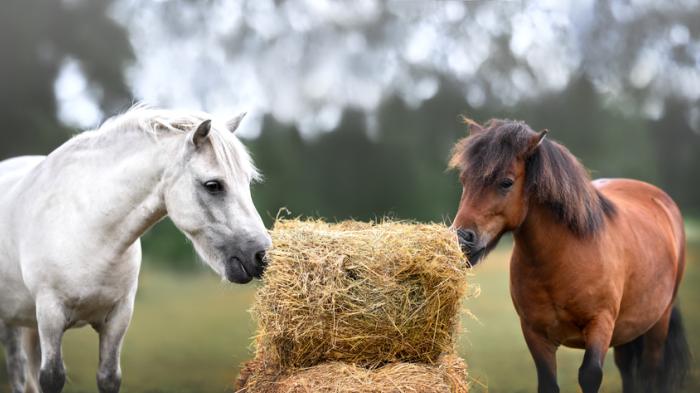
[96,104,262,181]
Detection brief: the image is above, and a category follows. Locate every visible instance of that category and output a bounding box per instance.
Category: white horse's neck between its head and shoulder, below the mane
[65,129,183,255]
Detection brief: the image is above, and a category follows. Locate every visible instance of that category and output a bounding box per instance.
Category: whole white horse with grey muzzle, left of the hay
[0,107,270,393]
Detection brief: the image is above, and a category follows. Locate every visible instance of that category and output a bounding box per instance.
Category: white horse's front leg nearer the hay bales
[94,297,134,393]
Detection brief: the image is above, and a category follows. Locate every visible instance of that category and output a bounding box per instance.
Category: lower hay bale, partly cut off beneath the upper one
[236,355,469,393]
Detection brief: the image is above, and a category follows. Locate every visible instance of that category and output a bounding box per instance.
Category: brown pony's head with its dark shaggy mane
[450,119,612,265]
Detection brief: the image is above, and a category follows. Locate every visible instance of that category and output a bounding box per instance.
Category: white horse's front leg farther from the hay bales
[36,296,68,393]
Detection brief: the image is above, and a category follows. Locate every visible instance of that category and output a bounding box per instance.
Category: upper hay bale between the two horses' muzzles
[253,220,467,368]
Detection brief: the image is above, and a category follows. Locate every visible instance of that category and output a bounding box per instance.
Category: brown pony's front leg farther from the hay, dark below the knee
[578,316,614,393]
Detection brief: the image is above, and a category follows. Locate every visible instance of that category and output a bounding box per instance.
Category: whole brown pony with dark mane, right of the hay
[450,120,690,393]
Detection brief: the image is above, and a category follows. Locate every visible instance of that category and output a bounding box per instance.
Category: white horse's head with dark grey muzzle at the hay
[163,115,271,283]
